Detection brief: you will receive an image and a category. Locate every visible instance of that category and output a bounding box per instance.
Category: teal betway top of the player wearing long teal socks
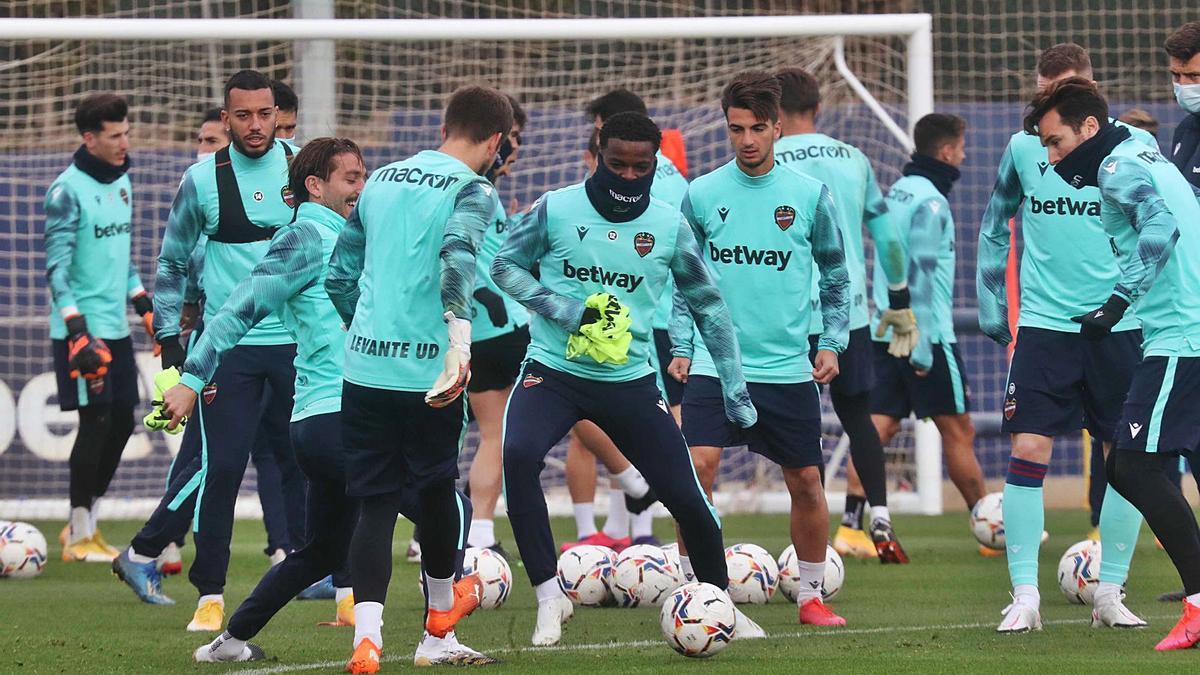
[976,123,1158,342]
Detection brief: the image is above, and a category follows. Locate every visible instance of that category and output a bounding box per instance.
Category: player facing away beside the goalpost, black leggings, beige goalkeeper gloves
[775,68,914,563]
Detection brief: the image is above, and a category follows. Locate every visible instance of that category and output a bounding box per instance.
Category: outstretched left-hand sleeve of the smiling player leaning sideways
[181,225,325,393]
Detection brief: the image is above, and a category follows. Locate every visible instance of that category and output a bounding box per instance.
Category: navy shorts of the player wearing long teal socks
[1000,327,1141,442]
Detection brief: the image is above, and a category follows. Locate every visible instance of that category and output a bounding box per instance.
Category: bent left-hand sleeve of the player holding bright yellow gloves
[492,197,583,333]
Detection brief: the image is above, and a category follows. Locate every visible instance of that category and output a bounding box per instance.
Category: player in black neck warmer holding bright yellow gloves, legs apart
[492,113,761,645]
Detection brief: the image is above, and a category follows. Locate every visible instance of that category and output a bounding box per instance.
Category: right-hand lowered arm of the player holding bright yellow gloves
[671,219,758,428]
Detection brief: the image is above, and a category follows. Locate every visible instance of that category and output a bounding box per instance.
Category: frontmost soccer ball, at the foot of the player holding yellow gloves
[659,581,737,658]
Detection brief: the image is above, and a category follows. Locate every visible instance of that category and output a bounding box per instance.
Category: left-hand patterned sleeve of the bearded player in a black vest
[154,172,204,342]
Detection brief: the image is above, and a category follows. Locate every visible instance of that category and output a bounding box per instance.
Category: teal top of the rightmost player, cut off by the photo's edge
[1088,138,1200,357]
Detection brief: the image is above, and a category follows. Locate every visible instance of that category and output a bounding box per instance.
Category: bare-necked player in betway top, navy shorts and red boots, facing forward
[671,71,850,626]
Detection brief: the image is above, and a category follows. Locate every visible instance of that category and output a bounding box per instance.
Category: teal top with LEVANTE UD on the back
[325,150,496,392]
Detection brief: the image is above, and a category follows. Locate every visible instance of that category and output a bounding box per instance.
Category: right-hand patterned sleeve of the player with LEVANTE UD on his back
[439,180,496,319]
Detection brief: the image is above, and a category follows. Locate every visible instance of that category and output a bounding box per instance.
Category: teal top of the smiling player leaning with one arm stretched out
[181,202,346,422]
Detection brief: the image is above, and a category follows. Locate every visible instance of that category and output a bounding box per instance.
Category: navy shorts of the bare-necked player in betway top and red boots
[683,375,824,468]
